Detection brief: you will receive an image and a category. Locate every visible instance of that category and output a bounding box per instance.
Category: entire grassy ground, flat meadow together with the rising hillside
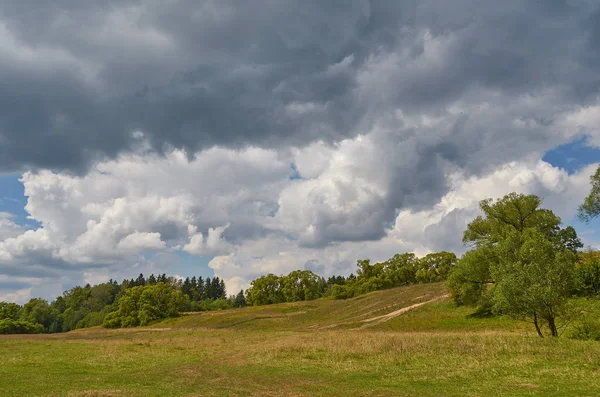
[0,284,600,397]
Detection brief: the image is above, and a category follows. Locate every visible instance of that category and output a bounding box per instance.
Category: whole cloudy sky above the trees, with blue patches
[0,0,600,303]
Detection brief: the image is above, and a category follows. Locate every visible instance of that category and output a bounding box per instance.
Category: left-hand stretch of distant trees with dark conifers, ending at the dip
[0,274,246,334]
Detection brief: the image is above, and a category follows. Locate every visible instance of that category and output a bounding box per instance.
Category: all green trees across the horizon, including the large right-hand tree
[5,168,600,339]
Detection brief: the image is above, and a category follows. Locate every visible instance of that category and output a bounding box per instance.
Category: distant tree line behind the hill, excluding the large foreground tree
[0,248,457,334]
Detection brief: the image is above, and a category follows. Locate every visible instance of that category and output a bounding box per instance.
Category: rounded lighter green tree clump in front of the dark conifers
[103,282,189,328]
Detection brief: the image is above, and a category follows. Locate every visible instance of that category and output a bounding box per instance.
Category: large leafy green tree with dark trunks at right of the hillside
[448,193,582,336]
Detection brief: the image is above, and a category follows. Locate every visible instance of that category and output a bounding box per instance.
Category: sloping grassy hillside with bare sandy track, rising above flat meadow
[163,283,524,332]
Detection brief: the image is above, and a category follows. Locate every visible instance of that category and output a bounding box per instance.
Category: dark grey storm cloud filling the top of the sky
[0,0,600,170]
